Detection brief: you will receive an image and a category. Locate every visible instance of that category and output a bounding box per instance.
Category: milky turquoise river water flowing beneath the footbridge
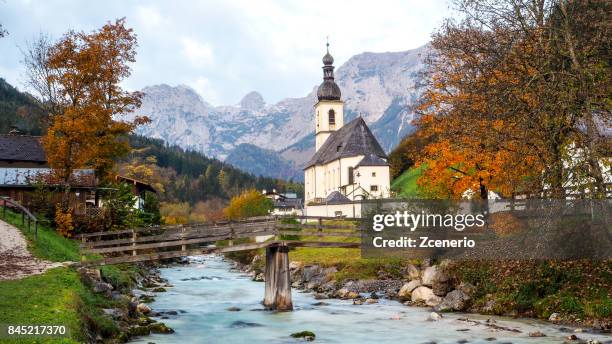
[133,256,611,344]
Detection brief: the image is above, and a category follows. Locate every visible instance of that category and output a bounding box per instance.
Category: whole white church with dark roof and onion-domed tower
[304,44,390,217]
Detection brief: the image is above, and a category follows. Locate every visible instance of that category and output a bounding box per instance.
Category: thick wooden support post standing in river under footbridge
[263,245,293,311]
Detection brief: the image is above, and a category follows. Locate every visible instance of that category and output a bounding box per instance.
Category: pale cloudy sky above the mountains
[0,0,451,105]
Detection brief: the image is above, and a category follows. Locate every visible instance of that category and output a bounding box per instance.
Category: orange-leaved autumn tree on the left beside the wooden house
[24,19,147,185]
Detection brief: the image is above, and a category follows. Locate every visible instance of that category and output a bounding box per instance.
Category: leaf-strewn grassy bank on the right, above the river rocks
[449,260,612,324]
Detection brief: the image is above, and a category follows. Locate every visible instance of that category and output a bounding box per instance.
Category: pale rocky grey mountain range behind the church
[131,45,429,181]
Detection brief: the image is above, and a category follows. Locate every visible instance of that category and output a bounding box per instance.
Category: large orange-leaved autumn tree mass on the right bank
[417,0,610,198]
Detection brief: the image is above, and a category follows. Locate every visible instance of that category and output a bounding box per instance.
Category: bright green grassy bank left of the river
[0,212,140,343]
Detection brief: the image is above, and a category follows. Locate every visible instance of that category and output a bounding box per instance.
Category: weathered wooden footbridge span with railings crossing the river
[78,216,360,265]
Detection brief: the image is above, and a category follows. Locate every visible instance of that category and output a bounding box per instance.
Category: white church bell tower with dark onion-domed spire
[315,43,344,151]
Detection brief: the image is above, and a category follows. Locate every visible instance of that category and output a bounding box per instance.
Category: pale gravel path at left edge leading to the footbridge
[0,221,64,280]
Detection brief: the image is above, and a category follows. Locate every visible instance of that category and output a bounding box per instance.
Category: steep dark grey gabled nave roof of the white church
[304,117,387,169]
